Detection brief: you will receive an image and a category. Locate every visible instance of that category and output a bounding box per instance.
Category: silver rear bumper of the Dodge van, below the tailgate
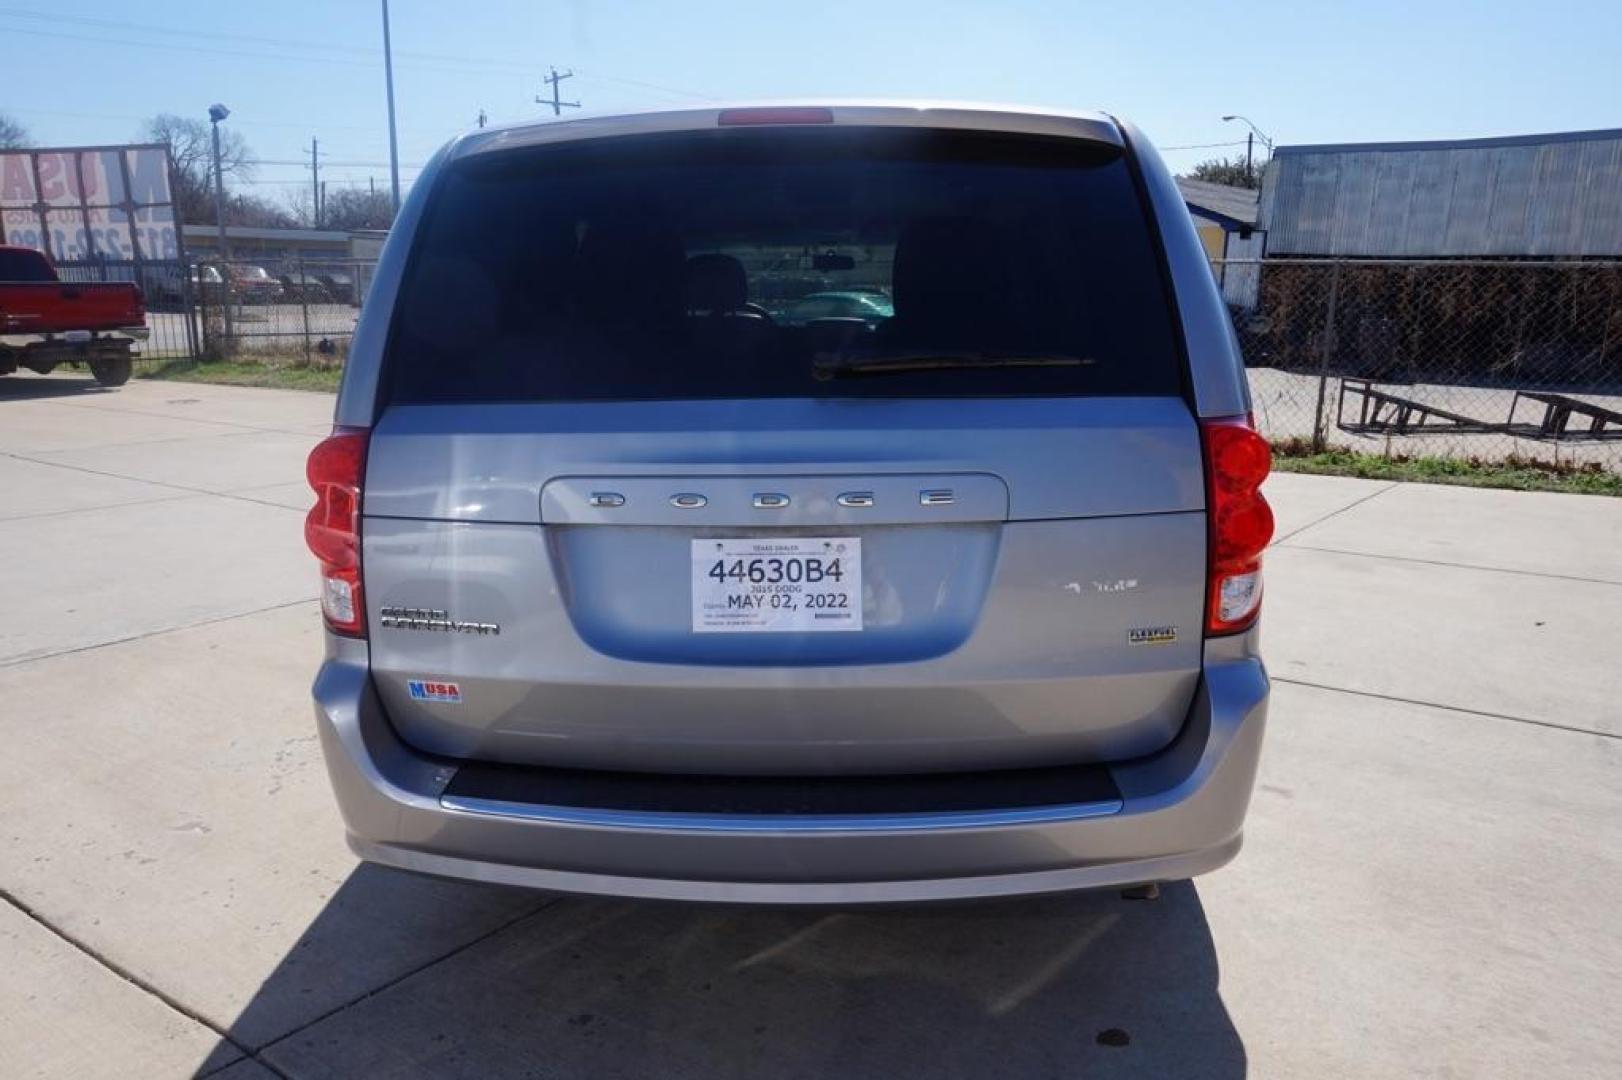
[315,644,1268,905]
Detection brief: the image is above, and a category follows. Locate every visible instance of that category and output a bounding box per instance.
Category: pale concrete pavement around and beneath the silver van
[0,378,1622,1080]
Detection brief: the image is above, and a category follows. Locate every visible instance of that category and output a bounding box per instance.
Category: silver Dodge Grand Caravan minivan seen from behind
[307,105,1273,903]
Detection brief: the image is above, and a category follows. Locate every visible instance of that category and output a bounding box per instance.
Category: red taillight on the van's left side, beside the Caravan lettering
[305,428,367,637]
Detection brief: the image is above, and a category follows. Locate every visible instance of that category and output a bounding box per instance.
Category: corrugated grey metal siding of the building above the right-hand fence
[1260,130,1622,258]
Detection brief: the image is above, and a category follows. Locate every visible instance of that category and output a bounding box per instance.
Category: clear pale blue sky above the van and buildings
[0,0,1622,201]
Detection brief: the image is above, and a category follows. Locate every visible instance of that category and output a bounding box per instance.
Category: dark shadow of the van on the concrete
[202,866,1246,1078]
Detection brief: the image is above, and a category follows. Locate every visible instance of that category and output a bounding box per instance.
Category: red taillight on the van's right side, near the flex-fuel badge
[1200,417,1273,634]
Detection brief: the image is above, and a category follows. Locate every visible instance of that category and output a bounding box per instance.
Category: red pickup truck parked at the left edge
[0,246,146,386]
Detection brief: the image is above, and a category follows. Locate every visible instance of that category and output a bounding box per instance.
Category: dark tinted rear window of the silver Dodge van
[384,128,1181,402]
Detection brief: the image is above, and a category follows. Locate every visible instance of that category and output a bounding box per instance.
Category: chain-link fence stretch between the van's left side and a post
[190,258,376,365]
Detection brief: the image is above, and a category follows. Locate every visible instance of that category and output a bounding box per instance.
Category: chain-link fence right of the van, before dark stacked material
[1213,259,1622,472]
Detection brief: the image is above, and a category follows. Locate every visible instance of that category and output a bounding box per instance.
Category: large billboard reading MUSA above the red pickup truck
[0,144,182,264]
